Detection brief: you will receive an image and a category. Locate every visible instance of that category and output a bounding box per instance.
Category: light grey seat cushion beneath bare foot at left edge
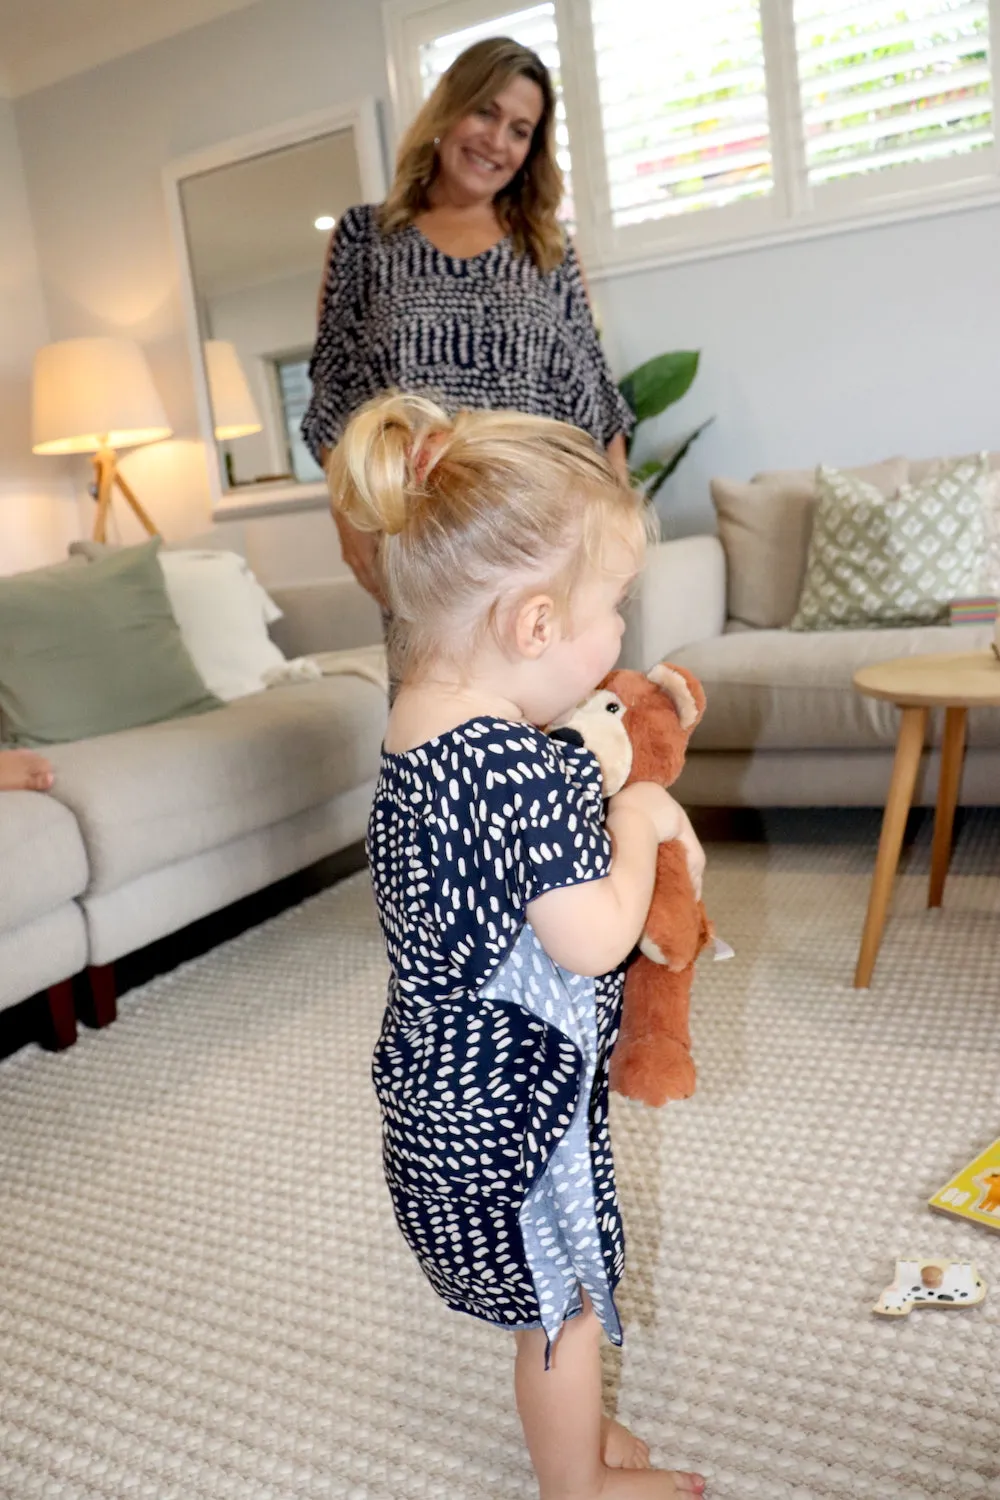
[0,792,87,932]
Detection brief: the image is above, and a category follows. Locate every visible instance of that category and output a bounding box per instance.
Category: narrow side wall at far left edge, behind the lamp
[0,98,79,573]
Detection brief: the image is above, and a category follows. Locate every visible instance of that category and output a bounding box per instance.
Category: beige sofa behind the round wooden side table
[625,456,1000,807]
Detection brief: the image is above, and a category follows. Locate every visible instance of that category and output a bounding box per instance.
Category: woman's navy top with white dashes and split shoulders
[301,204,634,461]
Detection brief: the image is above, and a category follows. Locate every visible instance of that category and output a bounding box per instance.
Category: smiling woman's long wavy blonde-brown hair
[379,36,565,272]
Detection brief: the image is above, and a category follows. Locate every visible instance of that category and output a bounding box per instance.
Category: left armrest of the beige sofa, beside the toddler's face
[619,537,726,672]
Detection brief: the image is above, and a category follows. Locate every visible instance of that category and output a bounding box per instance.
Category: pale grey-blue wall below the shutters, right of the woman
[597,207,1000,531]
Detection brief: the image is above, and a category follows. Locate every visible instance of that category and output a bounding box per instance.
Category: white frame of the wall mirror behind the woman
[163,98,388,521]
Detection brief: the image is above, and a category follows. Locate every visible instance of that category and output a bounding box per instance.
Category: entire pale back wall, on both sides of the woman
[16,0,1000,582]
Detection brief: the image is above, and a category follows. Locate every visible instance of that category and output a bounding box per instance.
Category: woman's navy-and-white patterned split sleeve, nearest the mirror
[301,206,375,464]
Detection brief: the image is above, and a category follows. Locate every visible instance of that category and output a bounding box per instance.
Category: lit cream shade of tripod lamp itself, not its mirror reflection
[31,339,171,453]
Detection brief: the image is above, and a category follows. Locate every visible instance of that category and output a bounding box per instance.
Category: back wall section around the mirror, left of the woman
[16,0,387,582]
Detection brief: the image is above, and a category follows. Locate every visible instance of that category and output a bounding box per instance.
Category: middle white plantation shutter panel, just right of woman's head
[591,0,774,230]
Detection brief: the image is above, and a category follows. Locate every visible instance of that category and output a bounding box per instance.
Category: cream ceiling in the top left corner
[0,0,256,96]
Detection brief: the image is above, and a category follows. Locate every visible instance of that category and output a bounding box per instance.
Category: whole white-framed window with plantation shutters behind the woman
[384,0,1000,267]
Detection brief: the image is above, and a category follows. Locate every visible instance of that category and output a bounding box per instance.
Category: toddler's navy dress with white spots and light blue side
[367,719,625,1343]
